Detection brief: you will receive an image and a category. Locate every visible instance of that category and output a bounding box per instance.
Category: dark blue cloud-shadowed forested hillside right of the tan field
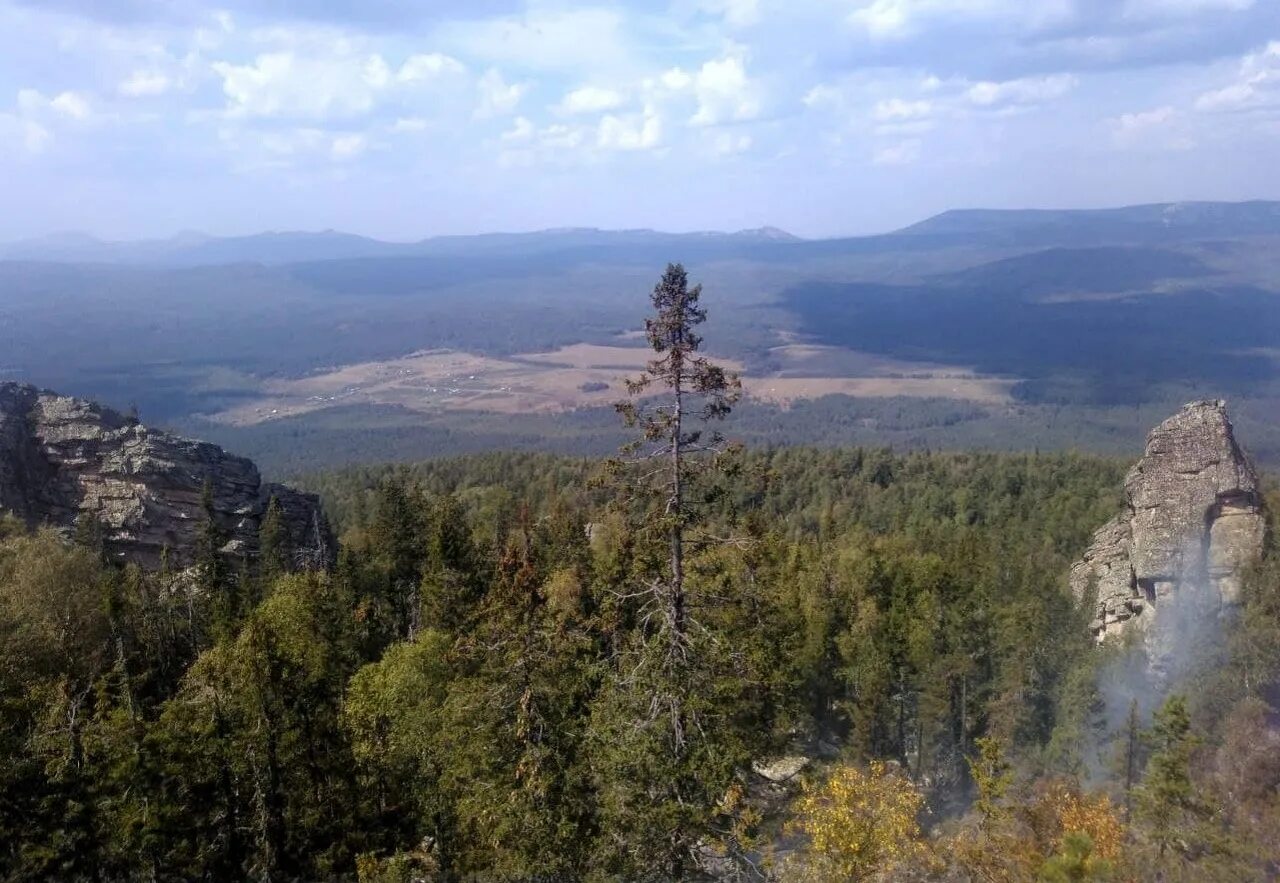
[783,248,1280,404]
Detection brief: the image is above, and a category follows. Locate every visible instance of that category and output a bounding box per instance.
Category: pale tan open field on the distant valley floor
[204,343,1015,426]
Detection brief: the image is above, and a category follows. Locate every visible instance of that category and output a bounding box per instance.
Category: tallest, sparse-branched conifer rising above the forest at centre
[594,264,749,879]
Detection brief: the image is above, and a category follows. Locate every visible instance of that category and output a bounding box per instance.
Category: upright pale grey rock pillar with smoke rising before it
[1071,402,1265,641]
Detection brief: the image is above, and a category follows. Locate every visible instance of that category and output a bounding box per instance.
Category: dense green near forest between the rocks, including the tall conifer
[0,264,1280,882]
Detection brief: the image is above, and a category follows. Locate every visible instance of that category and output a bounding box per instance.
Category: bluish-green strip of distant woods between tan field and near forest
[185,390,1280,477]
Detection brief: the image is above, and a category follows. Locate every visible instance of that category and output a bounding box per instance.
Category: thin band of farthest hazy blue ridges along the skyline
[0,201,1280,267]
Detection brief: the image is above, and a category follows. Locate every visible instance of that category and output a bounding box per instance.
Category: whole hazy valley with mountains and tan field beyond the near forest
[0,202,1280,471]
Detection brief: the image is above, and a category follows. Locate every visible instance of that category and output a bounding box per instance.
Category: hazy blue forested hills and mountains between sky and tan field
[0,202,1280,457]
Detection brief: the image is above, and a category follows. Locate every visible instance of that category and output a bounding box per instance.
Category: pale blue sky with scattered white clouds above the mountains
[0,0,1280,241]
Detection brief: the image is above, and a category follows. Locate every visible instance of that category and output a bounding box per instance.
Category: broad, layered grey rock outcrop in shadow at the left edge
[0,383,333,567]
